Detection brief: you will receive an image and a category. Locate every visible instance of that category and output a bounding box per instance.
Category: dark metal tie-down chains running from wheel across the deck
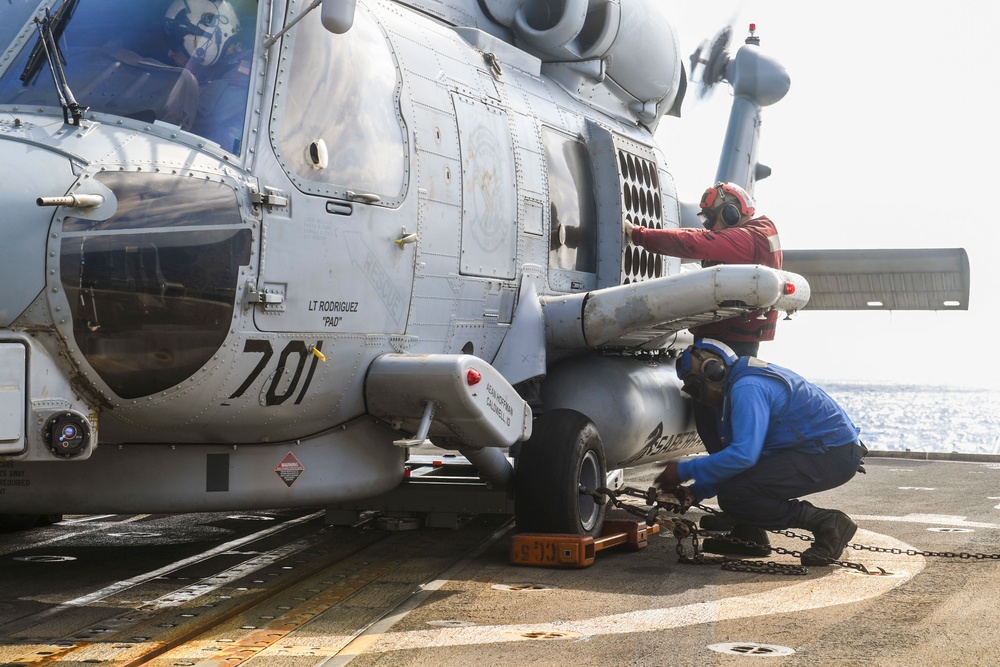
[580,486,1000,576]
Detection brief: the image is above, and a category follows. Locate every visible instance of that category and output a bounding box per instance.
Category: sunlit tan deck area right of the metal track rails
[334,456,1000,667]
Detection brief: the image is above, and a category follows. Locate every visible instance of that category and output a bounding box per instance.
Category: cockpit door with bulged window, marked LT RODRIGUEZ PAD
[254,6,416,335]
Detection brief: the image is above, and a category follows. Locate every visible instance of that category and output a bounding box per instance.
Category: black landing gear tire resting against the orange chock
[514,410,608,536]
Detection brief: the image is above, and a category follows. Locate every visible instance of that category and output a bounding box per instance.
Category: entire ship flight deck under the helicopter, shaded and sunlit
[0,455,1000,667]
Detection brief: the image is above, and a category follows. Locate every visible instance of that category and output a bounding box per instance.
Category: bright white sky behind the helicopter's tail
[657,0,1000,389]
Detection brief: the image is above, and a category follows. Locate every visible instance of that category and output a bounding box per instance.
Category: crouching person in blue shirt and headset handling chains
[656,338,867,565]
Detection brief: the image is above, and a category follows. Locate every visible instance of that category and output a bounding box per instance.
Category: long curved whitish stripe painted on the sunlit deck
[348,530,926,653]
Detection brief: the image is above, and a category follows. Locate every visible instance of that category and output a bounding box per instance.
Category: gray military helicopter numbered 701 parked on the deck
[0,0,968,534]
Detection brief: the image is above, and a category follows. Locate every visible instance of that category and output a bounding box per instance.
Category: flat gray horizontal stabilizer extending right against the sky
[783,248,969,310]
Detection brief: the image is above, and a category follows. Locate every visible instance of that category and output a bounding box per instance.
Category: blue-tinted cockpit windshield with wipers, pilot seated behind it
[0,0,257,154]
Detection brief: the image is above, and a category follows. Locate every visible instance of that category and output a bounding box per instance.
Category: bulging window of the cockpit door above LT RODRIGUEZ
[275,3,406,203]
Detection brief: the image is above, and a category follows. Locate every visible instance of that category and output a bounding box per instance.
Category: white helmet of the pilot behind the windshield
[164,0,240,67]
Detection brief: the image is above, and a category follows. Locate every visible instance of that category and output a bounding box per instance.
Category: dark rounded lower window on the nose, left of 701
[60,172,252,398]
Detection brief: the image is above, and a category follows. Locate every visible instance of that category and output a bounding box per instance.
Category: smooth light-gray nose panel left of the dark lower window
[0,136,75,327]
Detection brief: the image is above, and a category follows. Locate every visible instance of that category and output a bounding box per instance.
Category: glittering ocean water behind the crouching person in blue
[816,381,1000,454]
